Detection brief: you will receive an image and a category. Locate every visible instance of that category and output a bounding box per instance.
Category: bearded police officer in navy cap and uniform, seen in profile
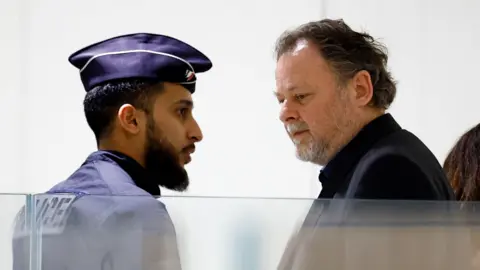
[13,33,212,270]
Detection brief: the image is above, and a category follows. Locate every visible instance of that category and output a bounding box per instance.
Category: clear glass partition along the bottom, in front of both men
[8,194,480,270]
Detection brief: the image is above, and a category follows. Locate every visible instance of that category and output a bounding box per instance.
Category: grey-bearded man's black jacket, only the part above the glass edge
[319,114,455,200]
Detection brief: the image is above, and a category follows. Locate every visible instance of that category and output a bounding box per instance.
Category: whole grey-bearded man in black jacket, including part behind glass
[275,19,454,270]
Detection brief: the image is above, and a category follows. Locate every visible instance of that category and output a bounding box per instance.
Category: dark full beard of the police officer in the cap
[145,119,189,191]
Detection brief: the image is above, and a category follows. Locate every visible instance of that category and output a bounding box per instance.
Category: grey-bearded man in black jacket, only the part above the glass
[275,19,454,200]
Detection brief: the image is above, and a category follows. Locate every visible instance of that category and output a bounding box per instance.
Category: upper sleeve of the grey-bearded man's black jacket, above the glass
[349,144,449,200]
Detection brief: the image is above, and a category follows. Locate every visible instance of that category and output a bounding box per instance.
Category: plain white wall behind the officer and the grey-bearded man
[0,0,480,269]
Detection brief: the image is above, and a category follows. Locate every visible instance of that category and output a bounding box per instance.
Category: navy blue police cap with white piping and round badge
[68,33,212,93]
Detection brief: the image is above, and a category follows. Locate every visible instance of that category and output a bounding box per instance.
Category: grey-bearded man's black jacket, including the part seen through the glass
[278,114,458,270]
